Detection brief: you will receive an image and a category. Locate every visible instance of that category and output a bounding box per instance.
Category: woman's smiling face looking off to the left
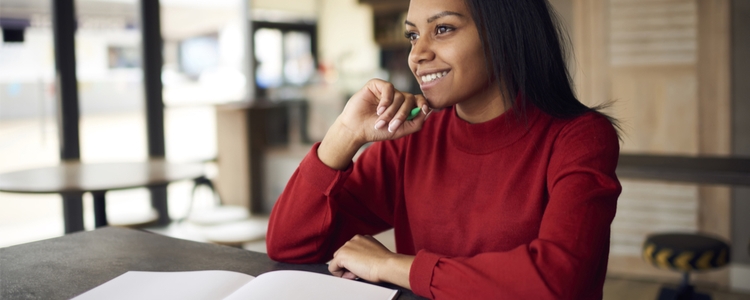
[406,0,498,108]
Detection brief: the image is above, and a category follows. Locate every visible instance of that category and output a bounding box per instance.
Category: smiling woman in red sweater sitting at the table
[267,0,621,299]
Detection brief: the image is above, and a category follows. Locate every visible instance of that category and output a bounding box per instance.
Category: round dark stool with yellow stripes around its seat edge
[643,233,729,300]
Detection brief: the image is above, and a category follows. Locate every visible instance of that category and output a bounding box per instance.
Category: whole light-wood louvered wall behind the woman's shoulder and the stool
[571,0,731,286]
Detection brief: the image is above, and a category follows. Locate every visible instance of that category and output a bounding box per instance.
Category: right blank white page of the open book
[225,271,398,300]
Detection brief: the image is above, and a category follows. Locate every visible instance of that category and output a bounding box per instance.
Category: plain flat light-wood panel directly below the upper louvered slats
[612,65,698,155]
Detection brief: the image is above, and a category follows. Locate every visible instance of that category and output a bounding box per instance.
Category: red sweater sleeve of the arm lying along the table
[409,114,621,299]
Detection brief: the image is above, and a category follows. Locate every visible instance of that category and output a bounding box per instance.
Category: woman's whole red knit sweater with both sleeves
[267,107,621,299]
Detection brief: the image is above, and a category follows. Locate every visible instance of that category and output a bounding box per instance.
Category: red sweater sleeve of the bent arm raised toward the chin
[266,143,402,263]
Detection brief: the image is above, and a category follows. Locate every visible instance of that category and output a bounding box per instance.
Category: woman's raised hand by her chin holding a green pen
[318,79,432,170]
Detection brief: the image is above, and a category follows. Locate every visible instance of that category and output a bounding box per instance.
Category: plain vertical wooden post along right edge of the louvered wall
[696,0,732,286]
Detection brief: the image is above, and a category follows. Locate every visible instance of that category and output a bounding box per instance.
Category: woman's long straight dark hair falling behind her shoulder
[465,0,619,129]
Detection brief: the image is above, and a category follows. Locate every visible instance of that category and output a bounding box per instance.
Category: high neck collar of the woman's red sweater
[446,104,541,154]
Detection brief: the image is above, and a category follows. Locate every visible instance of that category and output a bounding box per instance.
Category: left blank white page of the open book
[73,271,254,300]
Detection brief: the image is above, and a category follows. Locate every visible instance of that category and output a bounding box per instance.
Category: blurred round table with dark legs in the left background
[0,159,204,233]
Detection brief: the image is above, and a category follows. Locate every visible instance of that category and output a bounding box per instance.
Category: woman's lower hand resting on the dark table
[328,235,414,288]
